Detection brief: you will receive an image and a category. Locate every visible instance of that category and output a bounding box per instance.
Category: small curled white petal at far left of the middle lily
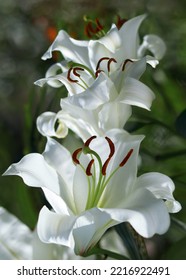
[36,112,68,138]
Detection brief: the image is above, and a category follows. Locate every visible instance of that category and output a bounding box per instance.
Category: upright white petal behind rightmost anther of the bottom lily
[98,131,144,208]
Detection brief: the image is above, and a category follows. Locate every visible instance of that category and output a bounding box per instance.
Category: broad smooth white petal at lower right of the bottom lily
[103,188,170,238]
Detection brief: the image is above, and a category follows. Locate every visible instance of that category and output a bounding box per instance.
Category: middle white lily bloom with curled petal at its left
[37,59,154,140]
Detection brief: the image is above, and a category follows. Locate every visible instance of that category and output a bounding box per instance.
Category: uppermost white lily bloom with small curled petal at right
[35,15,166,91]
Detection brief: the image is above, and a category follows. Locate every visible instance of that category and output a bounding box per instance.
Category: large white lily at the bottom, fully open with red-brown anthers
[2,130,181,255]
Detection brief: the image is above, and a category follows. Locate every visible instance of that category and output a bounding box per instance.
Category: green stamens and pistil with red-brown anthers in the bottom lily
[72,136,133,210]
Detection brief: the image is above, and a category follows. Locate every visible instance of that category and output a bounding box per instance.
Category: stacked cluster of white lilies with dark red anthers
[5,15,181,255]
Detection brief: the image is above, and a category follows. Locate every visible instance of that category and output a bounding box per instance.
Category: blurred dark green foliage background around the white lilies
[0,0,186,259]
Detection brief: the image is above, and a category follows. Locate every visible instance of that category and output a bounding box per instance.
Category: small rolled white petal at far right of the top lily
[138,34,166,60]
